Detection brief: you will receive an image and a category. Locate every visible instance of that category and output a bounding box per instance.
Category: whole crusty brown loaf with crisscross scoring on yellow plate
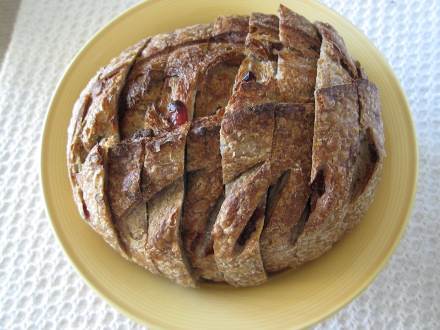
[67,5,385,287]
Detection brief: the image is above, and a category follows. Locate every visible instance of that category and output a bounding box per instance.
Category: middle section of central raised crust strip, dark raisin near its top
[220,63,277,184]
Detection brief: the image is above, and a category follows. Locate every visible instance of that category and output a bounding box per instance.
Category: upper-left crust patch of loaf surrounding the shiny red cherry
[121,24,213,138]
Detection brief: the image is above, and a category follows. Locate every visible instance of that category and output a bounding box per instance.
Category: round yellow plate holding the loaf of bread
[41,0,418,329]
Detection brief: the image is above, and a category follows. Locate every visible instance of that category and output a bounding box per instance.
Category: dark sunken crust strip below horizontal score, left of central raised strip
[182,112,224,281]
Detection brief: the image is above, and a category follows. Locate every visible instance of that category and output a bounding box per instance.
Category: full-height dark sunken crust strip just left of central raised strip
[182,16,249,281]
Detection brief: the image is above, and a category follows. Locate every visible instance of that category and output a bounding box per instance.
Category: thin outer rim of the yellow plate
[39,0,419,328]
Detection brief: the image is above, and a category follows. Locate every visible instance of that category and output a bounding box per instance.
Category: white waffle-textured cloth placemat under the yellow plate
[0,0,440,329]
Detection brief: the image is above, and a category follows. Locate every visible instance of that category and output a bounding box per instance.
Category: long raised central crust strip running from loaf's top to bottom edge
[212,13,279,286]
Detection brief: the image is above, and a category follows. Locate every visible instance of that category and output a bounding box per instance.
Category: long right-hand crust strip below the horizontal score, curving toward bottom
[291,84,359,267]
